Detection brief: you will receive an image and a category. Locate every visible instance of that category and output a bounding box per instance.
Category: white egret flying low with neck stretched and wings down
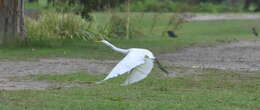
[96,40,168,85]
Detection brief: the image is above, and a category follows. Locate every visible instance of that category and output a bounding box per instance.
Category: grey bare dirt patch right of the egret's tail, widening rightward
[159,41,260,71]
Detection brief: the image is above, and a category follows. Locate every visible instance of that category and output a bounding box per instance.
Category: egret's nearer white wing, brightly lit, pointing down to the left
[104,52,145,80]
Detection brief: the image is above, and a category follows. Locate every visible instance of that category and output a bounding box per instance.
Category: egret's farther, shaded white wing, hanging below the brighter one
[123,58,153,85]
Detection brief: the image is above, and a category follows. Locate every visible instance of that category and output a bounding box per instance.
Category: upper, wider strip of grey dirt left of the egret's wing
[0,58,117,77]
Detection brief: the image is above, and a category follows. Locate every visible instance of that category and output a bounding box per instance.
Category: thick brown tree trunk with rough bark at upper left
[0,0,26,44]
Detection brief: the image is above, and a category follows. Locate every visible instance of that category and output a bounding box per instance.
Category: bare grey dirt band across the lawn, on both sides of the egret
[0,41,260,90]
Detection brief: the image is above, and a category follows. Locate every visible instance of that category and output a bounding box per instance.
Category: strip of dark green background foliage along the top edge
[25,0,260,12]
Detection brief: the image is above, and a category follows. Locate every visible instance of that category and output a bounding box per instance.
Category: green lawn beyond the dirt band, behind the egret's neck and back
[0,16,260,60]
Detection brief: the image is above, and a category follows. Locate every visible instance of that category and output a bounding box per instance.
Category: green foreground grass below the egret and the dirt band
[0,69,260,110]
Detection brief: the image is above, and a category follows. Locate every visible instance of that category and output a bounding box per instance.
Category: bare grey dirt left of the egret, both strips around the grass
[0,58,118,90]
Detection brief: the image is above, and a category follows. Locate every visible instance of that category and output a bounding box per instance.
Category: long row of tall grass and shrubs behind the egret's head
[25,12,148,46]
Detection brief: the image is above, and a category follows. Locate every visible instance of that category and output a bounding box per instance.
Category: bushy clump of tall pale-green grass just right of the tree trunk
[25,12,99,41]
